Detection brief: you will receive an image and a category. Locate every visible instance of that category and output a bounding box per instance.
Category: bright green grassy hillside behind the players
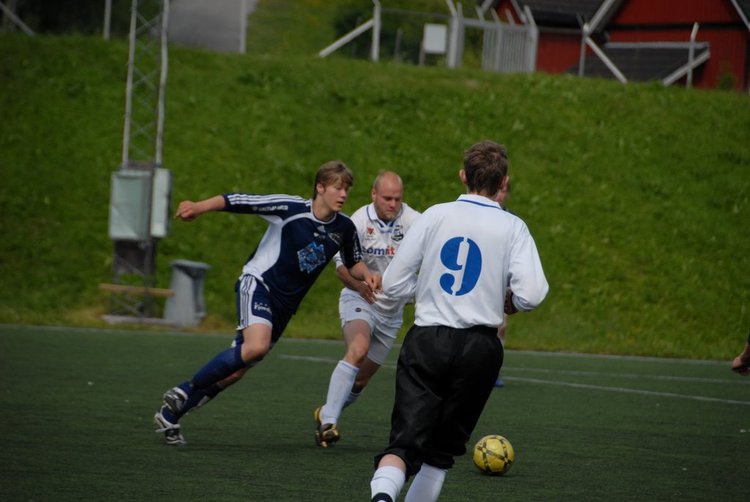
[0,24,750,359]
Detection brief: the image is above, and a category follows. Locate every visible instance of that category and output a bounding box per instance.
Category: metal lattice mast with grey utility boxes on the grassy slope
[109,0,171,317]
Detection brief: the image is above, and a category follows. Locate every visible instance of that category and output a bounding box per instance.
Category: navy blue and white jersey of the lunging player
[224,193,362,313]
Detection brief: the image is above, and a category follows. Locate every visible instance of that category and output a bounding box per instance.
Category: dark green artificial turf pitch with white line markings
[0,326,750,502]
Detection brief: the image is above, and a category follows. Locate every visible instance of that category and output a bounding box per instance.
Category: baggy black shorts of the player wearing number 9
[375,326,503,477]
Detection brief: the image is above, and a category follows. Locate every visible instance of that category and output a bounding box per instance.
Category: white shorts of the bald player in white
[339,291,403,366]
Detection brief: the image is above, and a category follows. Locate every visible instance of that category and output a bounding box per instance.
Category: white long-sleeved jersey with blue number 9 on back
[383,194,549,328]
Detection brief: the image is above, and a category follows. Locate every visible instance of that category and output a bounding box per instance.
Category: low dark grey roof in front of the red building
[568,43,710,85]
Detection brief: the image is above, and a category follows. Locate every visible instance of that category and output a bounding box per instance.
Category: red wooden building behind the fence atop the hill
[493,0,750,92]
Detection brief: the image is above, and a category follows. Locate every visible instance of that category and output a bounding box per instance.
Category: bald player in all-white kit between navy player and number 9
[313,171,420,448]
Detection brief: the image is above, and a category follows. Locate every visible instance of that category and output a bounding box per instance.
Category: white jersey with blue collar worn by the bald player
[335,203,421,317]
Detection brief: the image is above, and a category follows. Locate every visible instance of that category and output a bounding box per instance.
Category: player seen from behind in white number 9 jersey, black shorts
[370,141,549,502]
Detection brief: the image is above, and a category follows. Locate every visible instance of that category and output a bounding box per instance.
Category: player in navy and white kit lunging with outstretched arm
[154,161,380,444]
